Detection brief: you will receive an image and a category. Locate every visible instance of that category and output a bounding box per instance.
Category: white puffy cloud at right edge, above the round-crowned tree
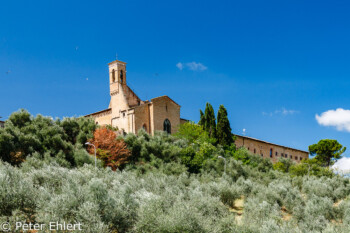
[316,108,350,132]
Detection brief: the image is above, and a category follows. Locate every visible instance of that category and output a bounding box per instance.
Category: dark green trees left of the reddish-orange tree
[0,110,96,166]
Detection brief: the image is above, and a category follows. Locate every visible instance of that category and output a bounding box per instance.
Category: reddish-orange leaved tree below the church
[88,127,131,171]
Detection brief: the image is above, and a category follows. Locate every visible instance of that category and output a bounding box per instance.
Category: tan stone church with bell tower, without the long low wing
[86,60,186,135]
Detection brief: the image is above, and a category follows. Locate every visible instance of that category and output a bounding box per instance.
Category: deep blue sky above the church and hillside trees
[0,0,350,155]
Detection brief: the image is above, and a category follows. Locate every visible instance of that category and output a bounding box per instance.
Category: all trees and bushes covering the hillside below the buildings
[0,111,350,233]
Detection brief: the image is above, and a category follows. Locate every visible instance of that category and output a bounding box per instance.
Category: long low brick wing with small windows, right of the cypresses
[235,135,309,163]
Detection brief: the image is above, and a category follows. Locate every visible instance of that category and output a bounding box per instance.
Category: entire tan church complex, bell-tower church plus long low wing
[85,60,309,163]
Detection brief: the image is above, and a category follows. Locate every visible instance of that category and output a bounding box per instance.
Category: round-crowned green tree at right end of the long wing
[309,139,346,166]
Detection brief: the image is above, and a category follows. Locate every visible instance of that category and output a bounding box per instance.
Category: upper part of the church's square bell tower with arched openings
[108,60,126,96]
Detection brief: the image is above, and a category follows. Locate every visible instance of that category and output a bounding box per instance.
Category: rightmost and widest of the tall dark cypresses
[216,105,233,146]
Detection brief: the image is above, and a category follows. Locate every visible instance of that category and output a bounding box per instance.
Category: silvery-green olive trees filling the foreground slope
[0,153,350,233]
